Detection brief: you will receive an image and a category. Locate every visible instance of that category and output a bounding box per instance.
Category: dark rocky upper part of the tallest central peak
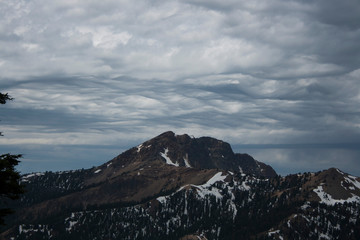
[107,131,277,177]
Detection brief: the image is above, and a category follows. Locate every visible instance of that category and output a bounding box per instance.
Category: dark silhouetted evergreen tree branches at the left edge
[0,93,24,225]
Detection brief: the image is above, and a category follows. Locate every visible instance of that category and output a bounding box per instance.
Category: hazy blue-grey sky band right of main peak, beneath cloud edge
[236,144,360,176]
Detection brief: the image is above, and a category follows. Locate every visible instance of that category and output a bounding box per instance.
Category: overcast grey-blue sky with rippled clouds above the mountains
[0,0,360,176]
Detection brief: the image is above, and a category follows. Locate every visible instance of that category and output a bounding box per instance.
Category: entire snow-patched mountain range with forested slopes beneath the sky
[0,132,360,240]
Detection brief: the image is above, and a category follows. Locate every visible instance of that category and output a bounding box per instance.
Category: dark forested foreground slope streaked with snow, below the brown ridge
[5,168,360,239]
